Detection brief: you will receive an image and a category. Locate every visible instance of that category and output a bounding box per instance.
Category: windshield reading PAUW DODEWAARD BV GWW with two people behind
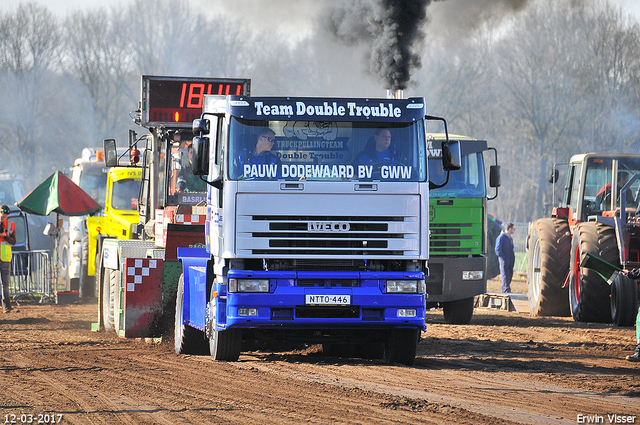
[228,117,427,182]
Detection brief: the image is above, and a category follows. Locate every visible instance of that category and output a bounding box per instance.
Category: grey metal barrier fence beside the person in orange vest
[9,251,59,303]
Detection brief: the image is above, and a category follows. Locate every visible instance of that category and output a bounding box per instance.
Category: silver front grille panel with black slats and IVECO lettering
[236,195,420,260]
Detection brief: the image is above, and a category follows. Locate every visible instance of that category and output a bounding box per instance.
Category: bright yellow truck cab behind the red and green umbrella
[87,167,142,276]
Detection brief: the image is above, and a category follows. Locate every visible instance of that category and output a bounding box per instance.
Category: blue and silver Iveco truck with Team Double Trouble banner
[175,95,460,365]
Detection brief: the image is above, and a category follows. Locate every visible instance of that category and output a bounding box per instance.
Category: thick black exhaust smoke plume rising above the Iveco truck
[329,0,431,90]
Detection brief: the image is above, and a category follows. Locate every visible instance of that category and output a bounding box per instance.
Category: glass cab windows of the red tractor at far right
[583,158,640,214]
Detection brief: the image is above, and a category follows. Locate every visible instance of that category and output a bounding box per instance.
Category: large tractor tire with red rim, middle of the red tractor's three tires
[569,222,620,323]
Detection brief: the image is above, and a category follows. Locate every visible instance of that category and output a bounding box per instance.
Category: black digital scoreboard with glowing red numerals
[140,75,251,127]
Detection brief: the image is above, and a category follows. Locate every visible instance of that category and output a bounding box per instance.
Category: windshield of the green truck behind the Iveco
[429,152,487,198]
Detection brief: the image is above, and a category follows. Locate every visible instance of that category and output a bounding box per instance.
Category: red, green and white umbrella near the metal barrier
[16,171,101,216]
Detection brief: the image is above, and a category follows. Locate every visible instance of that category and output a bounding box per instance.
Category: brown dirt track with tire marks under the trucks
[0,304,640,424]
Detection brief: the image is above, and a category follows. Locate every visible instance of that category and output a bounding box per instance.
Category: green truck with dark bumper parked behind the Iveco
[427,133,500,324]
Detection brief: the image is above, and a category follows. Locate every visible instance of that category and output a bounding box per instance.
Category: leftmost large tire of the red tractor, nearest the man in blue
[527,218,571,316]
